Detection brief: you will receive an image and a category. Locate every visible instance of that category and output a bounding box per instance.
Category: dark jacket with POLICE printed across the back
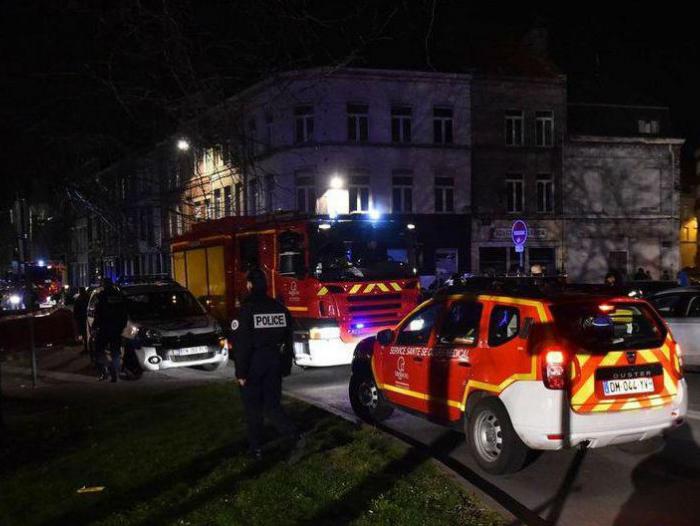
[231,294,294,378]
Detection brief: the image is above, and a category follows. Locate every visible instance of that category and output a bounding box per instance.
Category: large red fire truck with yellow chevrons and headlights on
[171,215,420,367]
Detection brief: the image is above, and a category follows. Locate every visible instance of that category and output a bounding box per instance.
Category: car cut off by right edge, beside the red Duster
[648,287,700,369]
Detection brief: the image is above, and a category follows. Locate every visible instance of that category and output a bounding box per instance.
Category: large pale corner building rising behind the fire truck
[180,69,471,280]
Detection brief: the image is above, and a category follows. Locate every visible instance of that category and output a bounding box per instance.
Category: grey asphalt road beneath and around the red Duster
[285,367,700,526]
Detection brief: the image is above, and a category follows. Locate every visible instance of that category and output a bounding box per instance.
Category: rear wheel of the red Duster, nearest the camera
[465,397,529,475]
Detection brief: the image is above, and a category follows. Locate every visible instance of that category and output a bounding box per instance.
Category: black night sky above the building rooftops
[0,0,700,206]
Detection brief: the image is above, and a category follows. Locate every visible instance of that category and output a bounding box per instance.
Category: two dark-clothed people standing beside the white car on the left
[73,278,127,383]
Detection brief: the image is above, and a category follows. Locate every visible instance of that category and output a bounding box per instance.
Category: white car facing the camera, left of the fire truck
[87,280,229,377]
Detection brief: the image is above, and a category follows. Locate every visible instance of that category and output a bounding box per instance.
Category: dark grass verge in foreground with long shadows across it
[0,384,501,526]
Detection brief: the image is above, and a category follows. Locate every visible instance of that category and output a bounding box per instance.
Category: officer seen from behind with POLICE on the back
[231,269,300,459]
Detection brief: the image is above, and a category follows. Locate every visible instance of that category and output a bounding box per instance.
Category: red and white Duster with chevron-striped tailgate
[349,289,687,474]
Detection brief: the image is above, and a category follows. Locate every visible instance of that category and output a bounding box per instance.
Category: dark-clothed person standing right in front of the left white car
[92,278,127,382]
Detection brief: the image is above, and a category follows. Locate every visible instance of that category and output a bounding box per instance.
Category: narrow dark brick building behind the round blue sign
[471,70,566,274]
